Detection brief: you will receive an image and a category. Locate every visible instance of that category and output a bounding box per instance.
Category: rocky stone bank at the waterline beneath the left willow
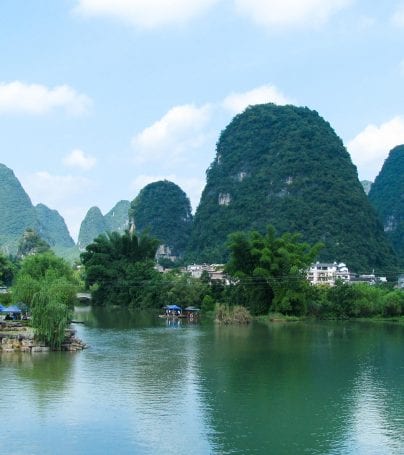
[0,321,87,353]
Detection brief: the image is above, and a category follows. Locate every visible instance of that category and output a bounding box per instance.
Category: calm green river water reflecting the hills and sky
[0,308,404,455]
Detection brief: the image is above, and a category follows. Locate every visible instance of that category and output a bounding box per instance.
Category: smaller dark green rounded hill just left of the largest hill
[129,180,192,256]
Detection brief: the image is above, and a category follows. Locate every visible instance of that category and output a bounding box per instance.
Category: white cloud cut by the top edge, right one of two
[235,0,351,27]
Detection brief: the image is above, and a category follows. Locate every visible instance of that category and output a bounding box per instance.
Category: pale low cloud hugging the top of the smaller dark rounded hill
[130,174,205,210]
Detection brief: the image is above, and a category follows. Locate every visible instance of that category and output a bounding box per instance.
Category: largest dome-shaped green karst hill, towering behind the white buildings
[188,104,396,272]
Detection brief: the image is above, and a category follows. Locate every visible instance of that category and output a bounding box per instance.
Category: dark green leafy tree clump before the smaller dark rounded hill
[81,231,160,307]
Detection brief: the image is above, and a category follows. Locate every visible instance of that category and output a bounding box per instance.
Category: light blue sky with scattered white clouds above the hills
[0,0,404,240]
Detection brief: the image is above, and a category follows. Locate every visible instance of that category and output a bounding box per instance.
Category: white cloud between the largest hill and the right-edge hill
[348,116,404,180]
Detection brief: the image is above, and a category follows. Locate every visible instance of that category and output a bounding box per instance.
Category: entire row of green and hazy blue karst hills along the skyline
[0,104,404,271]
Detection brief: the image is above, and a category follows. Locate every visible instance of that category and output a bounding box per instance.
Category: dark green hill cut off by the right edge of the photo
[369,145,404,267]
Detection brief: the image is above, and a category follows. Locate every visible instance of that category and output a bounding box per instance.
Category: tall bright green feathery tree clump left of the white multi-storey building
[226,226,322,314]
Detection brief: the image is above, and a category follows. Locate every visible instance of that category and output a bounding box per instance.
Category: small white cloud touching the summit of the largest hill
[222,85,292,114]
